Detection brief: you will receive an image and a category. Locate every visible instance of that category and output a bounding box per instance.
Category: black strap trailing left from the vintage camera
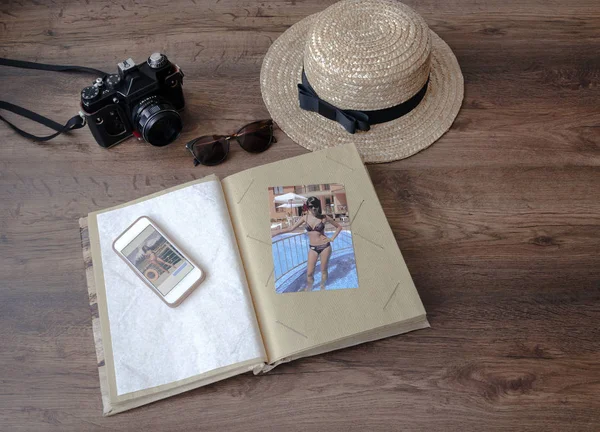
[0,57,107,141]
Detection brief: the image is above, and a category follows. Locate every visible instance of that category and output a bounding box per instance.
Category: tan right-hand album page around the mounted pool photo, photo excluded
[223,145,426,362]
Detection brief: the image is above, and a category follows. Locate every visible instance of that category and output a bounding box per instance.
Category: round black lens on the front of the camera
[133,96,183,147]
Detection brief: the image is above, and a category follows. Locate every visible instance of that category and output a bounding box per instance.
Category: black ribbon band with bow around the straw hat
[298,69,429,134]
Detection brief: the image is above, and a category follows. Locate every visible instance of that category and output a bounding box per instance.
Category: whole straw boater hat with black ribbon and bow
[260,0,463,162]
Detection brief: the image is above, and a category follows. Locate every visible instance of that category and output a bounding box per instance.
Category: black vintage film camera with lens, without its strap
[81,53,185,148]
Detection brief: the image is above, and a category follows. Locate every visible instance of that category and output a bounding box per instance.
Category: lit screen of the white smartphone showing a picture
[121,225,194,296]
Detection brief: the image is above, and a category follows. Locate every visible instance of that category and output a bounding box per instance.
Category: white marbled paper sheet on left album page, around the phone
[91,180,265,396]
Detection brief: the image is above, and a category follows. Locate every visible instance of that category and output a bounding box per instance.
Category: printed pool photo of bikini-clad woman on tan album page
[268,183,358,294]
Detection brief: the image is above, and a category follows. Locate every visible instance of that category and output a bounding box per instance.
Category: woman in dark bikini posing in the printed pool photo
[272,196,342,291]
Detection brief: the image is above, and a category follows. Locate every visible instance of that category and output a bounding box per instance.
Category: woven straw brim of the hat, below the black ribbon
[260,13,464,163]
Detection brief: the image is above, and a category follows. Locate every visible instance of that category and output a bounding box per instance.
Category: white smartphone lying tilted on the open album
[113,216,204,307]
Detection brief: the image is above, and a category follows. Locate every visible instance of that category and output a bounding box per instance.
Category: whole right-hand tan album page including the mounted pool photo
[222,145,428,364]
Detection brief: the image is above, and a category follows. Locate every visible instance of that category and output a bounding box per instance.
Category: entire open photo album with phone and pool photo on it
[80,145,429,415]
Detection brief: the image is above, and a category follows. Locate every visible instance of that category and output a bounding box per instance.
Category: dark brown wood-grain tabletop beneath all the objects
[0,0,600,432]
